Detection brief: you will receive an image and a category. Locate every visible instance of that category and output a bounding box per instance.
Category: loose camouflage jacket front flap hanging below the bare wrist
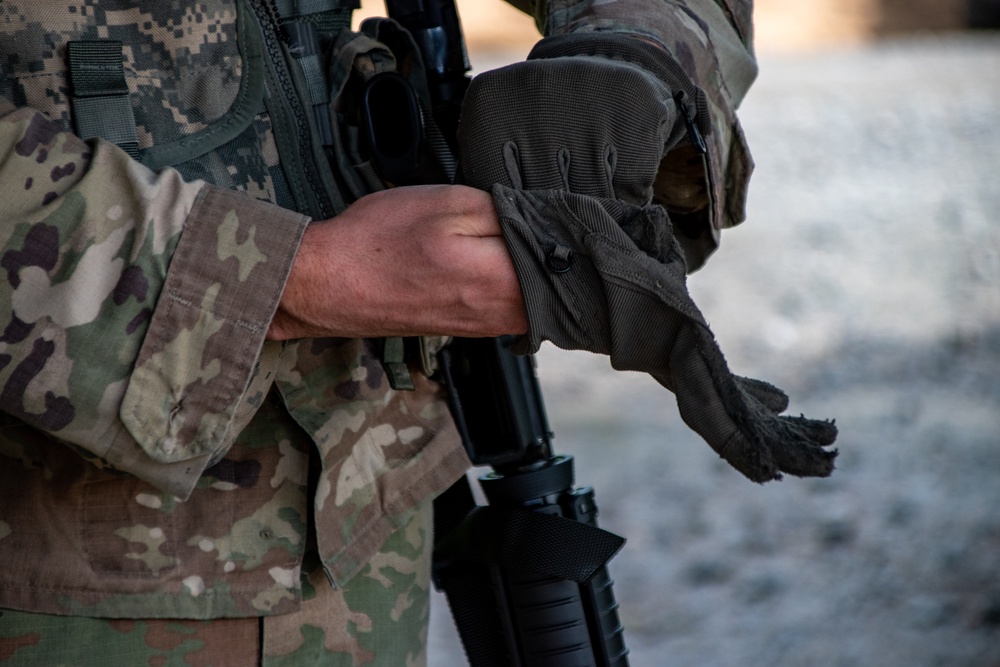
[275,340,470,582]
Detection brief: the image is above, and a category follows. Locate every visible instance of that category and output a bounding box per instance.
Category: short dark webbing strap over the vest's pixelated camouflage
[68,40,139,159]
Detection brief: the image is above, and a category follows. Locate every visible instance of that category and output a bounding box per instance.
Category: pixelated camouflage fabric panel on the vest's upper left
[0,0,286,193]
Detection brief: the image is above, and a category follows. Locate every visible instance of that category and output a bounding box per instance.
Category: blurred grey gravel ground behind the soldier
[429,34,1000,667]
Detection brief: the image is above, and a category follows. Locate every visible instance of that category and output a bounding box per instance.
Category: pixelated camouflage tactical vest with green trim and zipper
[0,0,454,219]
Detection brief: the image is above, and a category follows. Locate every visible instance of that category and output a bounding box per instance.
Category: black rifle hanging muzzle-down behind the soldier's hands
[386,0,628,667]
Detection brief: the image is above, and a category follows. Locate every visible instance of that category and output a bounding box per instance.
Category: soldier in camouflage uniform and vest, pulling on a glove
[0,0,832,665]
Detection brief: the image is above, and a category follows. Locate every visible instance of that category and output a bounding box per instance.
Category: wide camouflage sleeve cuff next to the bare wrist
[117,186,309,497]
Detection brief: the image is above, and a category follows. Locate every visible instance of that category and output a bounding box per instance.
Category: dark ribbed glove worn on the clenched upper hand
[458,37,687,204]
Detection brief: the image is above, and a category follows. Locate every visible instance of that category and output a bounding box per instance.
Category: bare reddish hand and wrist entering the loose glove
[267,185,527,340]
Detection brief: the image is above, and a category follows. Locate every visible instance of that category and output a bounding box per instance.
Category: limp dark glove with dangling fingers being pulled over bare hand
[493,185,837,482]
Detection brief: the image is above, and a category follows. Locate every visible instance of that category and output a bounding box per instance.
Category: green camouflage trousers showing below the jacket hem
[0,505,432,667]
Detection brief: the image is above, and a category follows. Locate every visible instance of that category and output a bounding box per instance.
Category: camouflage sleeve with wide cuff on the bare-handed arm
[0,98,308,498]
